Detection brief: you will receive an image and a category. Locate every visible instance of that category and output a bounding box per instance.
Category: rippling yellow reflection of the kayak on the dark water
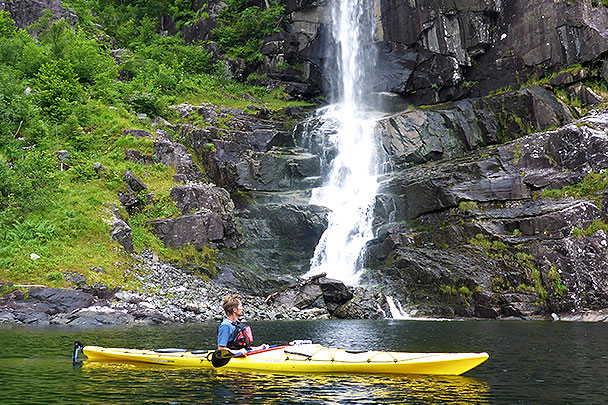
[81,362,489,404]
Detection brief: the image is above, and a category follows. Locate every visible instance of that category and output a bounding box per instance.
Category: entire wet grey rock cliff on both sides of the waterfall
[0,0,608,320]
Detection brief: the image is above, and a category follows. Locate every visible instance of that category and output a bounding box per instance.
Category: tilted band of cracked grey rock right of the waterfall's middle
[376,87,574,166]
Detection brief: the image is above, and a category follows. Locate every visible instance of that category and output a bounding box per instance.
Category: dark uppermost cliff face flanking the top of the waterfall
[288,0,608,105]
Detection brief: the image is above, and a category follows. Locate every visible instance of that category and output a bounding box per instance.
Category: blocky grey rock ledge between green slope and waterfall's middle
[181,106,319,191]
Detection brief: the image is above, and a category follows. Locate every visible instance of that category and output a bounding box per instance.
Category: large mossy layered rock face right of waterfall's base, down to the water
[366,111,608,318]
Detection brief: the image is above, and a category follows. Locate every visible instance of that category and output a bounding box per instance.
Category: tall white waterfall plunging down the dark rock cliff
[308,0,378,284]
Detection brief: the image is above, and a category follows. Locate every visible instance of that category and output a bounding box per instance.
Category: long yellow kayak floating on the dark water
[83,344,489,375]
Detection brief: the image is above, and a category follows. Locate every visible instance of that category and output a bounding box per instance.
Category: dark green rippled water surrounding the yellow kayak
[0,320,608,404]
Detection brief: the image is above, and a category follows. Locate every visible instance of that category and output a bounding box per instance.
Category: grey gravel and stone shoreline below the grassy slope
[0,250,330,326]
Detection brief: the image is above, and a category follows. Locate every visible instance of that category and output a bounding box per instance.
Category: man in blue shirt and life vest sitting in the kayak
[217,294,268,354]
